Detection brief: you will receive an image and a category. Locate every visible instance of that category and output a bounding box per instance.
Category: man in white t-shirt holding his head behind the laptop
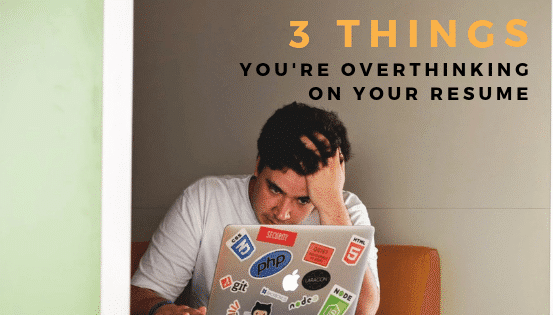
[131,102,380,315]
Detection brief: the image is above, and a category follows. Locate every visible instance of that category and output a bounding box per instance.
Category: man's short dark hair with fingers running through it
[257,102,351,176]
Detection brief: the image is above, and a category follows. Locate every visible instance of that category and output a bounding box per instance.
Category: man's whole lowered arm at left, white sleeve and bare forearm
[131,183,205,315]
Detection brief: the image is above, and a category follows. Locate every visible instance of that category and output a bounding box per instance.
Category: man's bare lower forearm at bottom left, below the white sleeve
[131,285,206,315]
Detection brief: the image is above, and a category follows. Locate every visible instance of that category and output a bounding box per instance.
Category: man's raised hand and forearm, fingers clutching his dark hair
[301,133,351,225]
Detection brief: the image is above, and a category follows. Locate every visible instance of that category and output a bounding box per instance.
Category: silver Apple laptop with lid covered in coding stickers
[207,225,374,315]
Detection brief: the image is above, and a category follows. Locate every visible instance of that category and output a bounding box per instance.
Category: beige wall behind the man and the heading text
[132,1,551,314]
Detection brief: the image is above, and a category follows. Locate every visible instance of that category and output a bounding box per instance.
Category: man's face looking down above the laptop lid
[249,166,314,224]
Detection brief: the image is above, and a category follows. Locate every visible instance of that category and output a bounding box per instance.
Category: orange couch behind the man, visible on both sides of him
[131,242,441,315]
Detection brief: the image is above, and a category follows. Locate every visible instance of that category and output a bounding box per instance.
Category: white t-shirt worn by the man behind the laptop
[131,175,379,308]
